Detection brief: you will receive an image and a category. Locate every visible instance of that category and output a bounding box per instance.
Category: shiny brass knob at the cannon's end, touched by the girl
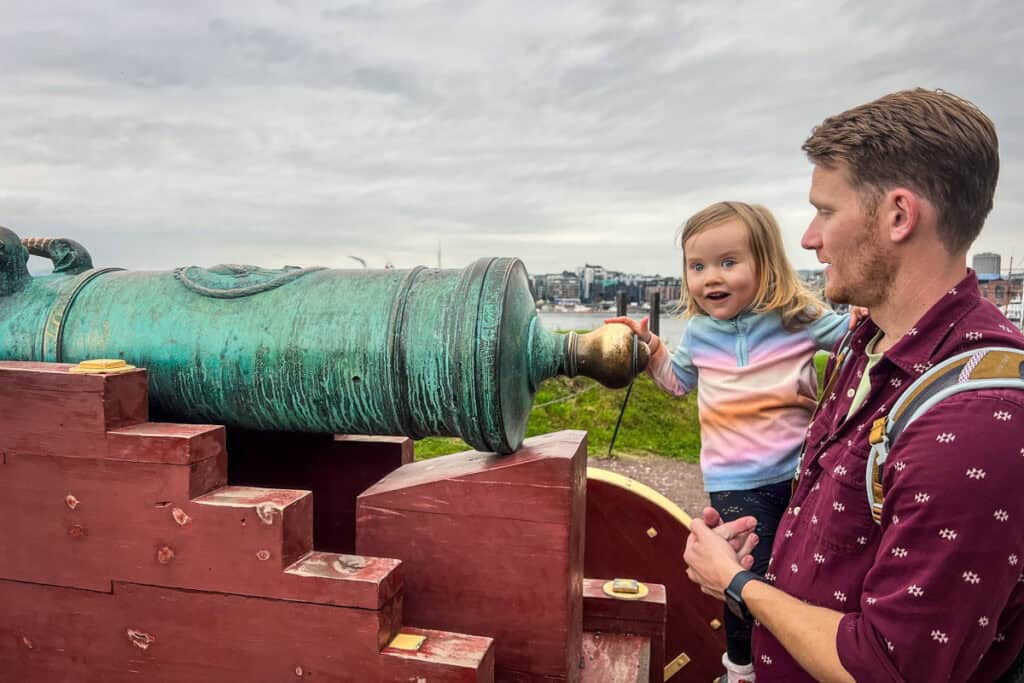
[563,324,650,389]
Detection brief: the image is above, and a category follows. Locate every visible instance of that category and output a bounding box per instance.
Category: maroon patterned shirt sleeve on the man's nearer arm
[837,391,1024,681]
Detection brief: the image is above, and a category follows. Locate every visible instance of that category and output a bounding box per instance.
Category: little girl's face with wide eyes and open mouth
[683,219,758,321]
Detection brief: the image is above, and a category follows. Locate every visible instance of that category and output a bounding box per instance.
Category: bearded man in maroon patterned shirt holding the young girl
[685,89,1024,683]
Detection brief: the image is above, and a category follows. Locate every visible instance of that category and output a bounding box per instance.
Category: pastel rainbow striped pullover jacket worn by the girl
[647,311,849,492]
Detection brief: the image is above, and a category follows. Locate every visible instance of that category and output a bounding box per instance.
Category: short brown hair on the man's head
[802,88,999,254]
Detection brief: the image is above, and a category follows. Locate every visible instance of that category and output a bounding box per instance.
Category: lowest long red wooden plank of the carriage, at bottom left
[0,581,493,683]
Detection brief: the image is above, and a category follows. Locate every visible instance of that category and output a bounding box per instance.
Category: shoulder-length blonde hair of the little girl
[677,202,825,330]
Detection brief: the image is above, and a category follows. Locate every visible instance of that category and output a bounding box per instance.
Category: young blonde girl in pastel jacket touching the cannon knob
[607,202,849,683]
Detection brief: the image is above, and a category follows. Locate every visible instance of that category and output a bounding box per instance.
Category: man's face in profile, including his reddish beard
[801,165,896,308]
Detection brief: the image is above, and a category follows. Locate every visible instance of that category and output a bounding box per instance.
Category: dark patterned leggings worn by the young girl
[708,481,791,665]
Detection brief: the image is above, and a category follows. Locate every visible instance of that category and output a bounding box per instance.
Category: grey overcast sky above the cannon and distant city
[0,0,1024,274]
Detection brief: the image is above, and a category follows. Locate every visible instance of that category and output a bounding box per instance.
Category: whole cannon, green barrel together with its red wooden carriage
[0,228,724,683]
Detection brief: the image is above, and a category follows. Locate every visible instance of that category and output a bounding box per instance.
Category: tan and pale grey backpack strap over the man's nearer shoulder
[864,346,1024,524]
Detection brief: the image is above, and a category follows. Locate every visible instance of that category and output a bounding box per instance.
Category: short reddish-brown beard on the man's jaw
[825,216,896,308]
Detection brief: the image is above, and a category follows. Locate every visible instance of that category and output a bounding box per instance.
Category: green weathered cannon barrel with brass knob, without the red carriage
[0,227,647,453]
